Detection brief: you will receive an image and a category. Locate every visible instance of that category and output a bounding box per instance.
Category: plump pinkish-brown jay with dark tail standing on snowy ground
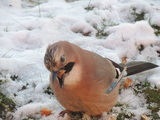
[44,41,158,116]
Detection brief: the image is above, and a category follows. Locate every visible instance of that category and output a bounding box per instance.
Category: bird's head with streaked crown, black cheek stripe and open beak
[44,41,75,87]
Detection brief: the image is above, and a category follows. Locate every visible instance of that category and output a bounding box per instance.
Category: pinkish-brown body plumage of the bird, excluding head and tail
[50,41,119,115]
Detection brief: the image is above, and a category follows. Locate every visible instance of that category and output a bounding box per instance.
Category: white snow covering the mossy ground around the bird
[0,0,160,120]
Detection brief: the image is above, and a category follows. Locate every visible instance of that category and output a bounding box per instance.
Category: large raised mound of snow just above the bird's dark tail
[103,21,157,58]
